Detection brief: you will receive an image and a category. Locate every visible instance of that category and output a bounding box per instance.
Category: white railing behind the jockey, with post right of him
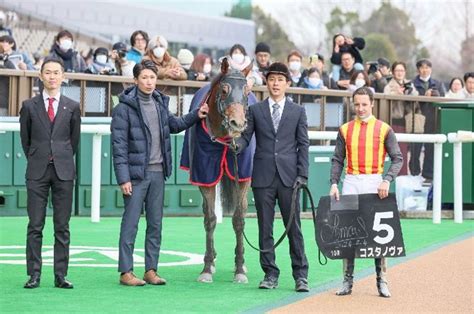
[308,131,446,224]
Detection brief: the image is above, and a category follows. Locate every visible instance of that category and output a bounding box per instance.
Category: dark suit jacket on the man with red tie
[20,94,81,180]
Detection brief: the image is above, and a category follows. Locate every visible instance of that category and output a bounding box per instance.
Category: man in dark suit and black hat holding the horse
[237,62,309,292]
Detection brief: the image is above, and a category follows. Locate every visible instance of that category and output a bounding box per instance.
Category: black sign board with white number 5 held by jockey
[316,194,405,259]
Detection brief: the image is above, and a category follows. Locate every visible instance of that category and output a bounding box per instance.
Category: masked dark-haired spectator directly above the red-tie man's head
[49,30,87,73]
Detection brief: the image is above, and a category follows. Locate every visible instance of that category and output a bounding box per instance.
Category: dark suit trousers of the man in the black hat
[253,172,308,280]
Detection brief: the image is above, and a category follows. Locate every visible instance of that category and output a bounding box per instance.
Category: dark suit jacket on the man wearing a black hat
[238,99,309,188]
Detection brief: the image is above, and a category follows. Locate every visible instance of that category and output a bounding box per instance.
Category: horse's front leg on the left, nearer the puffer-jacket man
[198,187,217,282]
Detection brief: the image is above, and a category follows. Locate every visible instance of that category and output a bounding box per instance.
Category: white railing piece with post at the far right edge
[448,131,474,223]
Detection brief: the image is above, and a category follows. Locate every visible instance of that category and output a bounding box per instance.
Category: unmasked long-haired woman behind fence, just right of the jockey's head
[383,61,419,175]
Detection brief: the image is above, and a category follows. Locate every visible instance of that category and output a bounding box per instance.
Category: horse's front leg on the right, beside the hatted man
[232,182,250,283]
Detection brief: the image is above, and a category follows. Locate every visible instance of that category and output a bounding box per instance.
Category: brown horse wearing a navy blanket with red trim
[181,58,257,283]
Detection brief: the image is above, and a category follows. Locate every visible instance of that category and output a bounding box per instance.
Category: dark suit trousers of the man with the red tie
[26,163,73,276]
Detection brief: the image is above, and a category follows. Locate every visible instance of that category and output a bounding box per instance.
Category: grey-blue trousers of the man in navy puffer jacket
[118,171,165,273]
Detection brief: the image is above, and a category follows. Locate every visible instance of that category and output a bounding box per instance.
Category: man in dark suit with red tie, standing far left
[20,57,81,289]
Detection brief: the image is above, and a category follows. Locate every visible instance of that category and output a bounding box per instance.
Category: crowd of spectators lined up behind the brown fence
[0,22,474,179]
